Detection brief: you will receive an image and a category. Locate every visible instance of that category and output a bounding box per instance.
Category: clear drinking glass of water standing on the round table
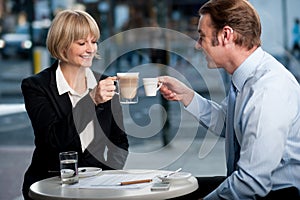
[59,151,79,185]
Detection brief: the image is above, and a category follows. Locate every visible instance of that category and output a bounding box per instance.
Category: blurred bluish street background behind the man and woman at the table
[0,0,300,200]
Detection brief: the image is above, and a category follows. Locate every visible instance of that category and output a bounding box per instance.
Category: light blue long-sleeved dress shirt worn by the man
[186,47,300,199]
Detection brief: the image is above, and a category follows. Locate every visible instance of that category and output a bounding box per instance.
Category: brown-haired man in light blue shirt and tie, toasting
[159,0,300,199]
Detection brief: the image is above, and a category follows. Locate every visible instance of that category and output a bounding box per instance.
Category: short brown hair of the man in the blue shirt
[199,0,261,50]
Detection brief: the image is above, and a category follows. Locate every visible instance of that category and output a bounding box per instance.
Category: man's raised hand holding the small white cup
[158,76,194,106]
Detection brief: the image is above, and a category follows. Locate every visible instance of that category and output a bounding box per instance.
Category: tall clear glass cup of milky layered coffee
[117,72,139,104]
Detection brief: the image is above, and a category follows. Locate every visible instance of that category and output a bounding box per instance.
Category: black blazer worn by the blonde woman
[21,61,128,198]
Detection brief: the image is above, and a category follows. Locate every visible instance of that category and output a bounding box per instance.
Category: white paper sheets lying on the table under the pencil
[69,173,160,189]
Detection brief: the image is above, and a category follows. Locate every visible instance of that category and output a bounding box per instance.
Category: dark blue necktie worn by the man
[225,83,240,176]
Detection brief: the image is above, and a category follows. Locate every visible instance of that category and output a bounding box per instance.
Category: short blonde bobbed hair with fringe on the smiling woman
[46,10,100,61]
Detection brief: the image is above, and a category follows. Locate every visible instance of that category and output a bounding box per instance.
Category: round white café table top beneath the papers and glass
[29,170,198,200]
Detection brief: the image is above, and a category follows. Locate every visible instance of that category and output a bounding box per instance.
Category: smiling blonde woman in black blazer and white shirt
[22,10,128,199]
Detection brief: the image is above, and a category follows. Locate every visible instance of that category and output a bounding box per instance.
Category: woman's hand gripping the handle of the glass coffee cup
[90,76,117,105]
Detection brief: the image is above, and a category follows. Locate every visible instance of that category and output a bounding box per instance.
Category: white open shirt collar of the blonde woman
[56,63,97,95]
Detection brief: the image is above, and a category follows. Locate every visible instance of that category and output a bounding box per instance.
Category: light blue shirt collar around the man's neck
[231,47,264,92]
